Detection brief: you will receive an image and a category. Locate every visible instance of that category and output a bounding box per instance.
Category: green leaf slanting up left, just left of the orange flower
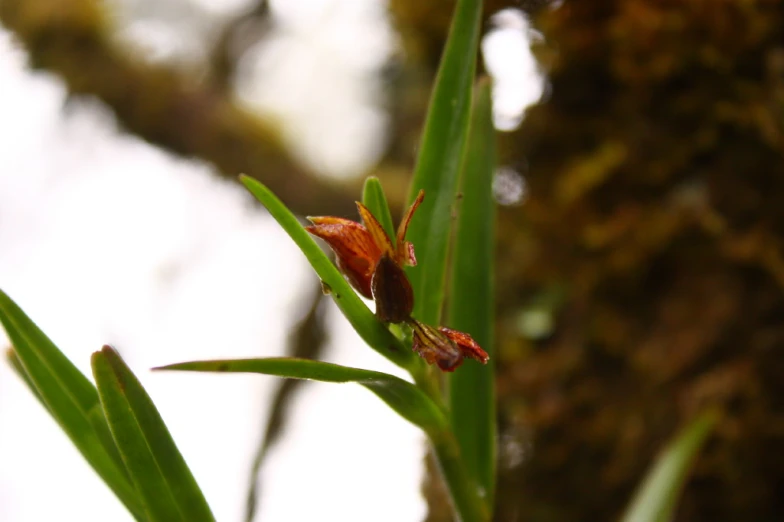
[240,175,417,369]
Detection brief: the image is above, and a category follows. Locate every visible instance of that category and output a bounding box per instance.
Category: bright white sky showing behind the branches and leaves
[0,0,541,522]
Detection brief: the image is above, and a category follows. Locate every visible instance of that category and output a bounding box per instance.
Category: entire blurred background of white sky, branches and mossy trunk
[0,0,784,522]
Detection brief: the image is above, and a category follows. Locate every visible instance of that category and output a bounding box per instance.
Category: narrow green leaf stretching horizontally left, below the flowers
[155,357,447,434]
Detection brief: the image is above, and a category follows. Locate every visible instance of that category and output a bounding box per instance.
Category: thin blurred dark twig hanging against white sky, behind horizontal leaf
[245,284,327,522]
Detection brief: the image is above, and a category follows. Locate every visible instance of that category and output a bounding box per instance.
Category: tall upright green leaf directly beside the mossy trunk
[448,80,496,507]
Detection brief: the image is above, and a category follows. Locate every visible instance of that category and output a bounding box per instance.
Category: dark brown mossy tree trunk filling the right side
[497,0,784,522]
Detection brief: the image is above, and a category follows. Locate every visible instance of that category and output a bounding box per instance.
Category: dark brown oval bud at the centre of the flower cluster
[370,254,414,323]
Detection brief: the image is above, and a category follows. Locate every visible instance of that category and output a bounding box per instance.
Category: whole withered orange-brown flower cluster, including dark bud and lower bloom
[305,190,489,372]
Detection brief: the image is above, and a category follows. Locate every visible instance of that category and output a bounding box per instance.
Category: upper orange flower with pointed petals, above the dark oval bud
[305,190,425,302]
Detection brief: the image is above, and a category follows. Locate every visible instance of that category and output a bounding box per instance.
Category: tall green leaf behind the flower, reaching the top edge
[407,0,482,325]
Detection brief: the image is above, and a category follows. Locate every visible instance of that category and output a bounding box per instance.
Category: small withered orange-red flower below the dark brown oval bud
[408,319,490,372]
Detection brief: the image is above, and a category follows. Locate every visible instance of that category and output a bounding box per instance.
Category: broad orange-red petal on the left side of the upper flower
[305,216,381,299]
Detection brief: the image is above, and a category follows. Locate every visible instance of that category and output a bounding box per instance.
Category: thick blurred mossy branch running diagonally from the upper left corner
[0,0,360,215]
